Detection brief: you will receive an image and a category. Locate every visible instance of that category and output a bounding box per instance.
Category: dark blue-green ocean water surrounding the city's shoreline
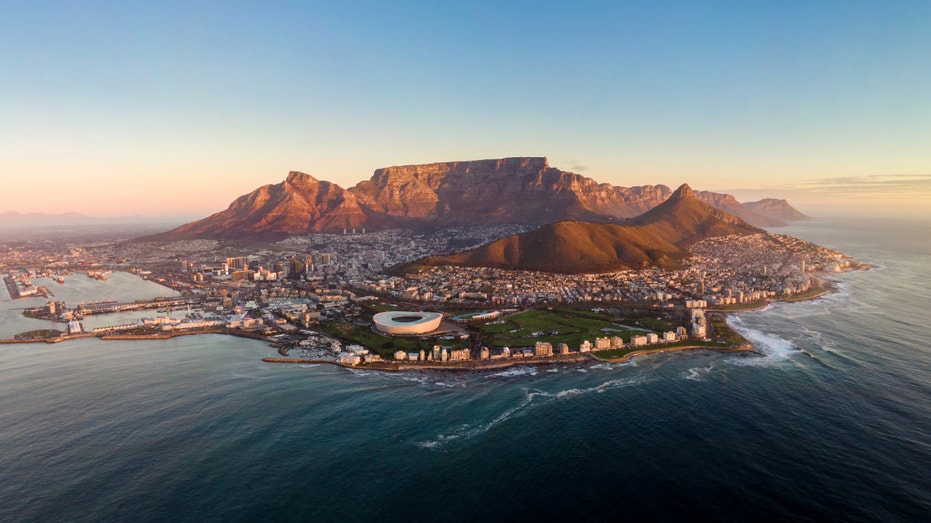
[0,222,931,521]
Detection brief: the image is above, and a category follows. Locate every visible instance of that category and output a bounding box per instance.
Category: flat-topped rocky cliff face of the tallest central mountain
[350,158,669,225]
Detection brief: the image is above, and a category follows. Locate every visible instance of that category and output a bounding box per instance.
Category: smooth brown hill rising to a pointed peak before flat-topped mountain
[408,185,764,274]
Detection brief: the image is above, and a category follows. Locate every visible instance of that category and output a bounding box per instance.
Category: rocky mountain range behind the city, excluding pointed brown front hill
[149,158,804,239]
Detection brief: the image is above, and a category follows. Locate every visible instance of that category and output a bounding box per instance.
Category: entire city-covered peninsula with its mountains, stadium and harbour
[0,158,862,370]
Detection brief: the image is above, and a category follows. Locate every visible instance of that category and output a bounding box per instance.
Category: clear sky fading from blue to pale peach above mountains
[0,0,931,218]
